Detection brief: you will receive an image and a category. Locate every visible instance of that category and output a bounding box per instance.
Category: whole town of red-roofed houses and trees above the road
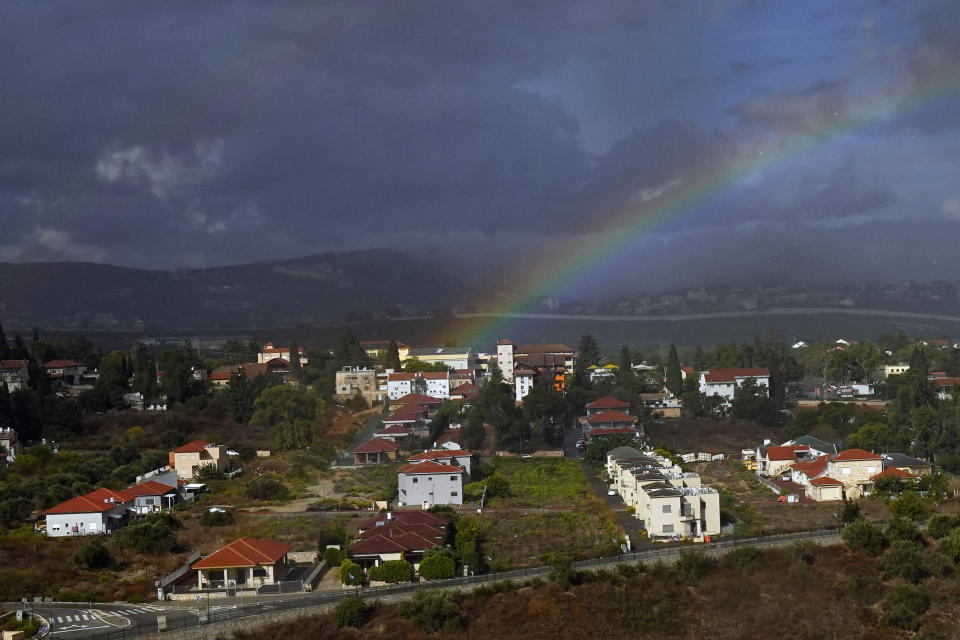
[0,331,960,637]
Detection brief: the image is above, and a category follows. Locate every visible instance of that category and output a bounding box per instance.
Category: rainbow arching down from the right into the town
[444,69,960,348]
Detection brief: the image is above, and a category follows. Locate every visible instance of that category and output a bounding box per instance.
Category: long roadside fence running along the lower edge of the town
[34,529,840,640]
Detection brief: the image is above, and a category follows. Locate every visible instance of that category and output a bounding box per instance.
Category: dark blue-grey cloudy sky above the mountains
[0,0,960,298]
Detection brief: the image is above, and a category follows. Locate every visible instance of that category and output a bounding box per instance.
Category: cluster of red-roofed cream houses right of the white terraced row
[749,436,932,502]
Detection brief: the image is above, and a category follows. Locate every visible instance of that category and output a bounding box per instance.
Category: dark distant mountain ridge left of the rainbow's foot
[0,250,473,330]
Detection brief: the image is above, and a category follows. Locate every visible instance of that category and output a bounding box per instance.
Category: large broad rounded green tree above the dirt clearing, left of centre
[250,385,324,449]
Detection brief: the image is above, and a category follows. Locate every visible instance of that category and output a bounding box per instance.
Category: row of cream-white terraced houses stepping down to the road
[607,447,720,542]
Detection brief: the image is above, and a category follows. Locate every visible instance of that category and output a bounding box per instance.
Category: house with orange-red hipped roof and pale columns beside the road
[191,537,293,589]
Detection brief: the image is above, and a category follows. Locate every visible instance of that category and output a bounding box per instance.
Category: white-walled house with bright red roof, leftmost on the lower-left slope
[43,488,136,538]
